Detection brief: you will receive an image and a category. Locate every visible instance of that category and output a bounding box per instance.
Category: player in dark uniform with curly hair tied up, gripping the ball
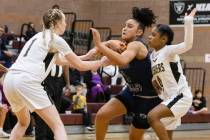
[92,7,161,140]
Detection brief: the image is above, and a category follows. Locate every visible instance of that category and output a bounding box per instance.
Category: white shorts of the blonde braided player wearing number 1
[3,71,52,112]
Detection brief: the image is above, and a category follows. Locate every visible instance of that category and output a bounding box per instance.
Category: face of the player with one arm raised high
[148,27,162,49]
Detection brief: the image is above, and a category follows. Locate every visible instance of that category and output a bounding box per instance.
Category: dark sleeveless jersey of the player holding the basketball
[120,38,157,96]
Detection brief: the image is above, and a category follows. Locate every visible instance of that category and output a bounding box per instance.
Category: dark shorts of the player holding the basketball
[115,89,162,129]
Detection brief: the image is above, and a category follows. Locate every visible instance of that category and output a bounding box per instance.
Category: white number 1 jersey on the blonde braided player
[10,30,72,81]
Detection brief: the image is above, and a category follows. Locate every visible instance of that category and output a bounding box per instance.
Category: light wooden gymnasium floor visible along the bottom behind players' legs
[0,130,210,140]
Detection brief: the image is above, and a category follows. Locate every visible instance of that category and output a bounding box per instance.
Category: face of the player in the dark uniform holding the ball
[121,19,140,42]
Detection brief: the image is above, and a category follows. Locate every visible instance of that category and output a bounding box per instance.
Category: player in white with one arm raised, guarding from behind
[148,9,196,140]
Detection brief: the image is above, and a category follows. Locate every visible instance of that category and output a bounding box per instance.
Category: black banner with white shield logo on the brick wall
[169,0,210,26]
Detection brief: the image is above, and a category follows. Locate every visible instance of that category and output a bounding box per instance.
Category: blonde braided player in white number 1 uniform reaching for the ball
[1,9,103,140]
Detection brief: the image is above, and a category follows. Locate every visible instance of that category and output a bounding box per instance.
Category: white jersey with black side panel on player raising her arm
[150,16,193,100]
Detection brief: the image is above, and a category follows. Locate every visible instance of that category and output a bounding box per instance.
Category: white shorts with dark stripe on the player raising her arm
[161,91,192,130]
